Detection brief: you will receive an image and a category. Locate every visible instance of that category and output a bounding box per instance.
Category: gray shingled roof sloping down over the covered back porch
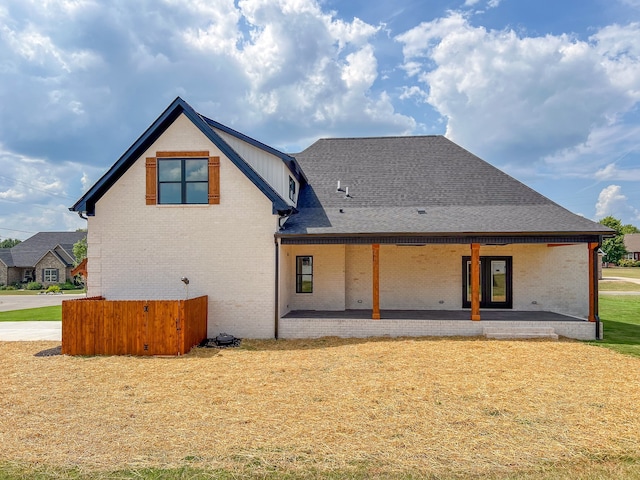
[279,136,608,236]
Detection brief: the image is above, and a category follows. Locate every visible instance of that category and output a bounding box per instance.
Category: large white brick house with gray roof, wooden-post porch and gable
[70,98,611,338]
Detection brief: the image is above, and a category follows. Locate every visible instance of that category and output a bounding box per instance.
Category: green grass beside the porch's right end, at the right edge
[592,295,640,357]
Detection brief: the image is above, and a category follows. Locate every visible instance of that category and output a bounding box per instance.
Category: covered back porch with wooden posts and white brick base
[277,237,600,339]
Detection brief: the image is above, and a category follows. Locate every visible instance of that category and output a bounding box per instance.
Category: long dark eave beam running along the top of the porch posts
[280,234,601,245]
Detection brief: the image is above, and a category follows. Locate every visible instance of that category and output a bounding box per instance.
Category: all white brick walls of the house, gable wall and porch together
[88,115,591,338]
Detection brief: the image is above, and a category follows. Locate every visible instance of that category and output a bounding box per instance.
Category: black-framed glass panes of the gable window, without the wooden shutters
[158,158,209,204]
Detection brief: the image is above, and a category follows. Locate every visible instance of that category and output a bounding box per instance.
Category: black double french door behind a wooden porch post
[462,257,513,308]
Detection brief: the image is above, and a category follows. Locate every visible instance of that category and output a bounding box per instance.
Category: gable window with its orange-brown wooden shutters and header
[146,151,220,205]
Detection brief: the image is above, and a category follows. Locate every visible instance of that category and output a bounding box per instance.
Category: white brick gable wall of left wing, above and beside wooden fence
[87,115,277,338]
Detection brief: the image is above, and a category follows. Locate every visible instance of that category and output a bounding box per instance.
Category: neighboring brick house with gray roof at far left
[0,232,87,287]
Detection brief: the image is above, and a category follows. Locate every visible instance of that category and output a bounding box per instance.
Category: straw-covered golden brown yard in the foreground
[0,339,640,476]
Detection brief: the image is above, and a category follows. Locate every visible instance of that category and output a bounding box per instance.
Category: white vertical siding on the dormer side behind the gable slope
[213,128,300,206]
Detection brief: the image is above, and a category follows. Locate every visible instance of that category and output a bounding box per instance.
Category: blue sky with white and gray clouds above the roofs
[0,0,640,239]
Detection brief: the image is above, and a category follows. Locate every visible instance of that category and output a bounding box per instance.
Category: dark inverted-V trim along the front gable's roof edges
[69,97,290,215]
